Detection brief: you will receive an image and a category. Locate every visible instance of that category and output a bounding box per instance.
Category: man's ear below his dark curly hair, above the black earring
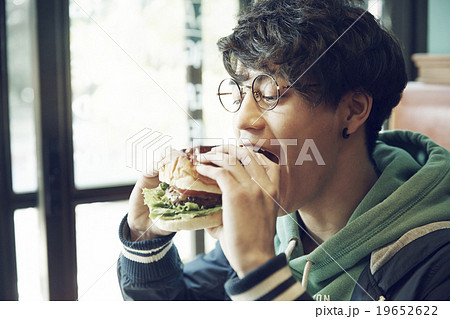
[339,92,373,134]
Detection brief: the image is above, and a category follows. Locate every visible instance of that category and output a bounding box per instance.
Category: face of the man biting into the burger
[233,72,341,215]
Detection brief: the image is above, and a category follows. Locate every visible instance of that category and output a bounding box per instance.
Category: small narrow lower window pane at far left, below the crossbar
[14,208,43,300]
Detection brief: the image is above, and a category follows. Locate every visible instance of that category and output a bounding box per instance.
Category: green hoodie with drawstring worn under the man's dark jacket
[275,131,450,300]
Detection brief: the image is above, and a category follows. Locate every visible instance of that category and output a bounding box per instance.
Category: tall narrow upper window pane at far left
[6,0,37,193]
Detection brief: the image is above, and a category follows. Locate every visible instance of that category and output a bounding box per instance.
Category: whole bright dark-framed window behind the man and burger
[0,0,239,300]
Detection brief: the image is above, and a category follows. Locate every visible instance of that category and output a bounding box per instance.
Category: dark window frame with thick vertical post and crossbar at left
[0,0,209,300]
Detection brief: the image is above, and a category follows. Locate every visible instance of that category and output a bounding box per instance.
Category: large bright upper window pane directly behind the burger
[70,0,188,188]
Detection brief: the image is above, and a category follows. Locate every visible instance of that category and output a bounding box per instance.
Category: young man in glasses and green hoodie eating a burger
[118,0,450,300]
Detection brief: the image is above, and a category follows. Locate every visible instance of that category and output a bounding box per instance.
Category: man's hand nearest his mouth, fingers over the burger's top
[197,145,280,277]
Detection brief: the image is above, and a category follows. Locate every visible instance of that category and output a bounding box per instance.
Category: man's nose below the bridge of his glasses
[234,92,264,130]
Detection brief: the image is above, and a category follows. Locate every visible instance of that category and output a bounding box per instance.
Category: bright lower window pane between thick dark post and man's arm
[76,201,193,301]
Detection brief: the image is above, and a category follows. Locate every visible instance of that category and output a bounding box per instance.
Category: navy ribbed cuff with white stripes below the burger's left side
[119,216,181,281]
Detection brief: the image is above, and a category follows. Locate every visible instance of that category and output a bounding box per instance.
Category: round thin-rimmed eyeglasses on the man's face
[217,74,290,113]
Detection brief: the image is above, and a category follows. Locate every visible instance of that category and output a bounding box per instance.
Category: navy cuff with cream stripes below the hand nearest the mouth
[225,254,312,301]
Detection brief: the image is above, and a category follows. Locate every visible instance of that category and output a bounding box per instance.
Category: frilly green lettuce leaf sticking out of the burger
[142,183,222,220]
